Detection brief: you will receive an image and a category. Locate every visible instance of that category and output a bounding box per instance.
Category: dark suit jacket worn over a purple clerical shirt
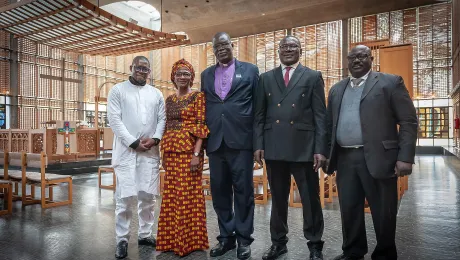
[201,60,259,153]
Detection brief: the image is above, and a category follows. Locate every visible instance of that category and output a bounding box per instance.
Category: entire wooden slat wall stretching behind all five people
[0,0,452,128]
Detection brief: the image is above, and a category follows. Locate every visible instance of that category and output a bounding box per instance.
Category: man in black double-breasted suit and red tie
[254,36,328,260]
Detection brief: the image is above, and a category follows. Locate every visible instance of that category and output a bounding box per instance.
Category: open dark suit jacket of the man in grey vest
[327,71,418,179]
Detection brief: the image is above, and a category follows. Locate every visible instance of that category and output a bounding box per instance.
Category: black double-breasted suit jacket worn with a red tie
[254,63,328,162]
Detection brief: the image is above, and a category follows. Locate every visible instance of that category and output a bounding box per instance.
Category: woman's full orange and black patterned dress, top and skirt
[156,92,209,256]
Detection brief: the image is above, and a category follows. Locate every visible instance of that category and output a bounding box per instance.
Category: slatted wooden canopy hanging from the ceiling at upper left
[0,0,189,56]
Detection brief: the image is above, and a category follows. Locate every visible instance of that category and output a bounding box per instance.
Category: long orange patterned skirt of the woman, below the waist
[156,152,209,256]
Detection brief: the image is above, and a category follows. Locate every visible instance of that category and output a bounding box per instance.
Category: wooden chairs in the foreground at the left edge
[0,151,72,213]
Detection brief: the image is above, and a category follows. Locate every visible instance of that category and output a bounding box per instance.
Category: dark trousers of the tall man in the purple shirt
[208,142,254,245]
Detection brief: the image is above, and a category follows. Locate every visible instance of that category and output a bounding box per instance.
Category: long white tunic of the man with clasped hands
[107,81,166,198]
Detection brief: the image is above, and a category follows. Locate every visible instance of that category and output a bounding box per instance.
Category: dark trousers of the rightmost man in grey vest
[337,148,398,260]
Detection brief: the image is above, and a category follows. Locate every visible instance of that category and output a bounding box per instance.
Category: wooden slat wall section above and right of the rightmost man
[349,3,452,98]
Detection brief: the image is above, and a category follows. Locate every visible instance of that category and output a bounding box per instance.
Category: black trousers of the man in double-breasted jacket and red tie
[266,161,324,249]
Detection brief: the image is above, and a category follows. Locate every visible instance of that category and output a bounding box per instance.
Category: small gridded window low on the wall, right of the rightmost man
[417,107,449,139]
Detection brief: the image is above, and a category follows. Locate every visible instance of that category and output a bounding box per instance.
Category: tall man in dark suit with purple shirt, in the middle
[201,33,259,259]
